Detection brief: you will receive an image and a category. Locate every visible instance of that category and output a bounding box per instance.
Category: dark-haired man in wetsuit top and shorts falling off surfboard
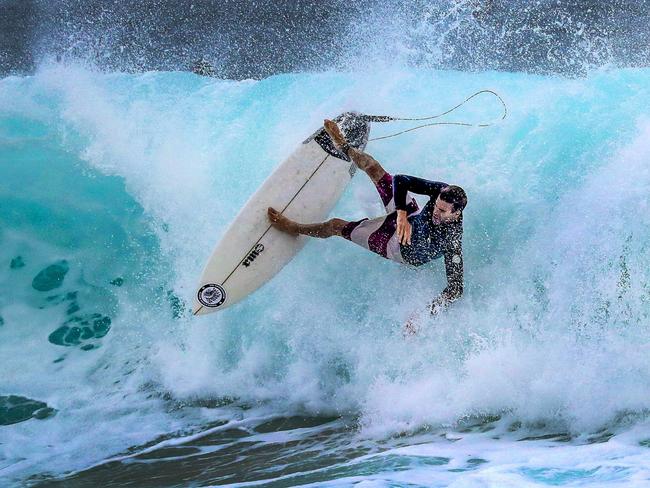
[268,120,467,334]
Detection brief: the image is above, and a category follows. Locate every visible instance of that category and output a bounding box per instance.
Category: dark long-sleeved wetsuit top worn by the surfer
[393,175,463,300]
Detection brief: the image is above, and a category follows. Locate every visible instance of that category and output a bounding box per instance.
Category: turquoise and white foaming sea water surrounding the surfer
[0,65,650,486]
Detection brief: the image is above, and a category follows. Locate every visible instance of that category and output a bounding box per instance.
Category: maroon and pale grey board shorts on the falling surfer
[341,173,420,263]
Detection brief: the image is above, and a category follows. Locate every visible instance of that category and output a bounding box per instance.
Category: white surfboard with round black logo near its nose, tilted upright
[192,112,370,315]
